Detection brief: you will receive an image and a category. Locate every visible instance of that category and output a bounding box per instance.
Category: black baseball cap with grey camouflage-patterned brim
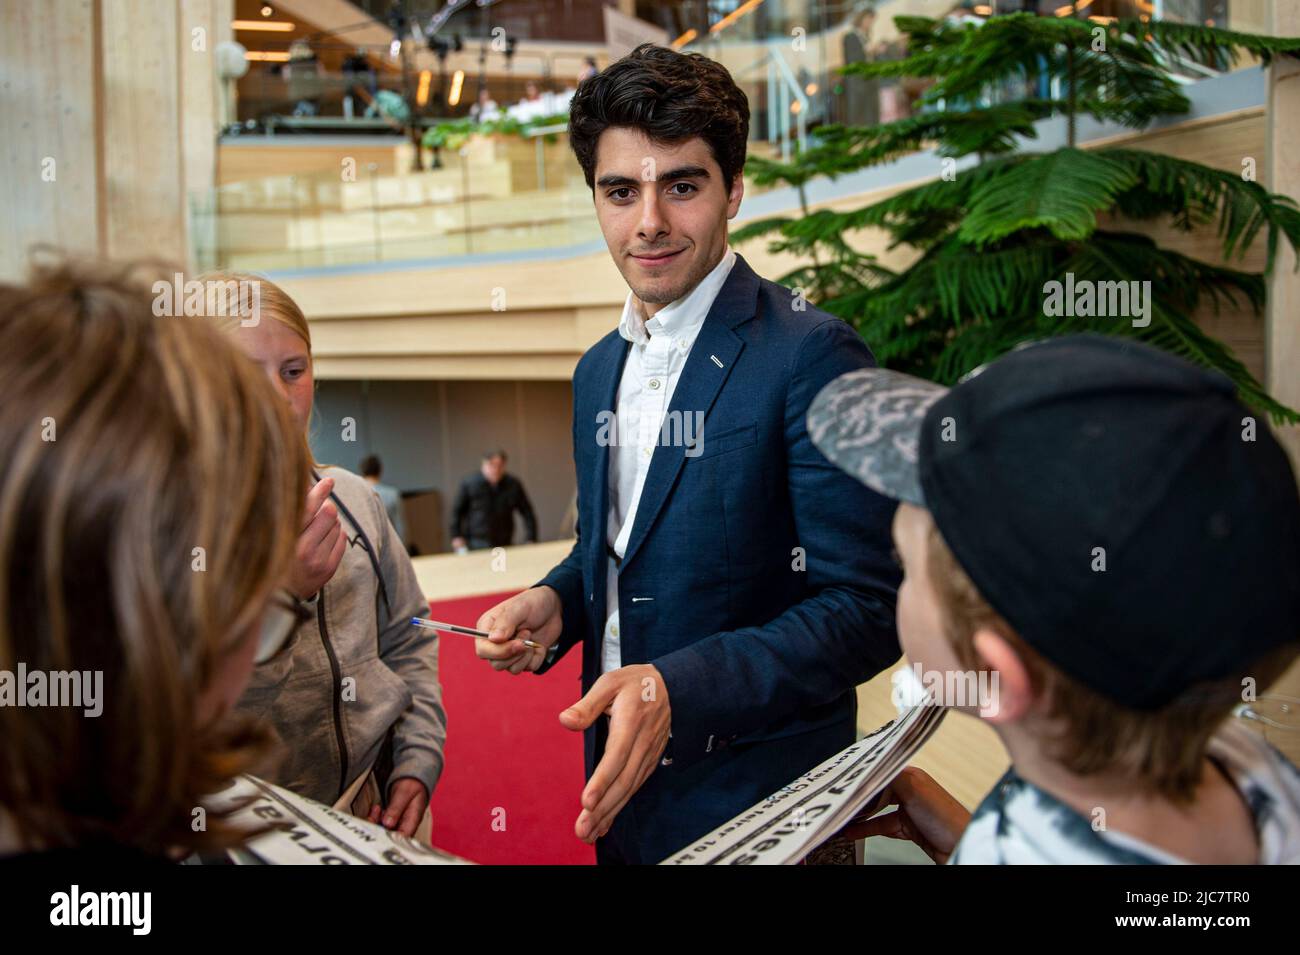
[807,335,1300,711]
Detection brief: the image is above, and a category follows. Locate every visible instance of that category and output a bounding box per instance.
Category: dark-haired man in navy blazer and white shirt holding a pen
[477,44,900,863]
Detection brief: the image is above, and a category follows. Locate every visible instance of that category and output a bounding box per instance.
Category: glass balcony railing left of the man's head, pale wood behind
[190,125,599,272]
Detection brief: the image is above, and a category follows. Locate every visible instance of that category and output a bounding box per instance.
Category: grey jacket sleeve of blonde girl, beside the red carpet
[376,488,447,796]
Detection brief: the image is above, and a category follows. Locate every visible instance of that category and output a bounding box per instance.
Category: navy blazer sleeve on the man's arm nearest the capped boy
[651,318,900,764]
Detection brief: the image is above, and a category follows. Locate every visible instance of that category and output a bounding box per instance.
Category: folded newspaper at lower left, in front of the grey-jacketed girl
[191,776,471,865]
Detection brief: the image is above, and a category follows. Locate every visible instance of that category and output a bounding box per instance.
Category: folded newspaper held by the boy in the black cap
[659,702,946,865]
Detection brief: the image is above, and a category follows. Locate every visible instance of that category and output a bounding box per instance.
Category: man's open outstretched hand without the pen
[560,664,672,843]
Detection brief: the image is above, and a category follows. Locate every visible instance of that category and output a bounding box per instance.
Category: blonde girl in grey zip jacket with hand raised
[202,273,447,845]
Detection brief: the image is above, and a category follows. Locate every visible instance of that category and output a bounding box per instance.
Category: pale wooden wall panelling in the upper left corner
[0,0,233,278]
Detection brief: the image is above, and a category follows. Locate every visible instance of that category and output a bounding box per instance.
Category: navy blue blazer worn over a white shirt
[540,255,900,863]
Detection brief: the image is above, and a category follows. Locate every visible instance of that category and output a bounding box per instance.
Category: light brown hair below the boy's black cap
[926,520,1297,804]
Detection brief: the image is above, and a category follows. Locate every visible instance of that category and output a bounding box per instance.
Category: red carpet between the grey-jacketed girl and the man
[429,592,595,865]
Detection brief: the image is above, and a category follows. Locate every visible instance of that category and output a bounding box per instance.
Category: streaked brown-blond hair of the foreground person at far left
[0,257,308,854]
